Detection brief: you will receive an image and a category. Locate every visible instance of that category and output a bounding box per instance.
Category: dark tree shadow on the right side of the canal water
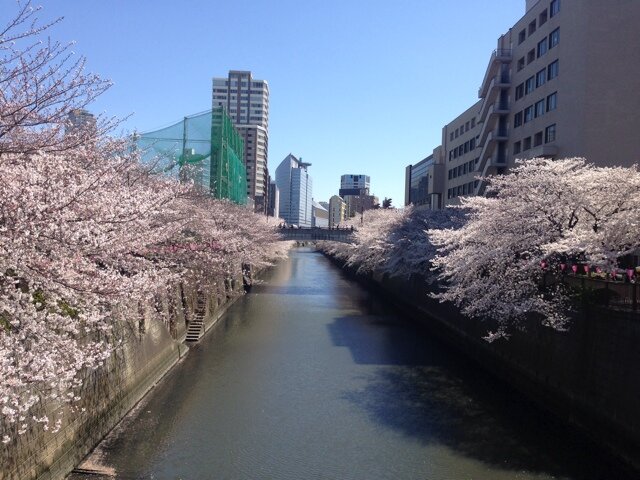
[328,296,635,480]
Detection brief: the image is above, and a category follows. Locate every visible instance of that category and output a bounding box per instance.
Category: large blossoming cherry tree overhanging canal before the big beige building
[429,158,640,340]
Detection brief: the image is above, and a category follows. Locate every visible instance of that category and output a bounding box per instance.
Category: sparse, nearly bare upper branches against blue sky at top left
[0,1,118,156]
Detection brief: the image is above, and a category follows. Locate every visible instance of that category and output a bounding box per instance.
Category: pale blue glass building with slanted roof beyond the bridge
[276,154,313,227]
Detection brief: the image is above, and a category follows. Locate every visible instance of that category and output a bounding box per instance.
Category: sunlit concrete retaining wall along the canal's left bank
[0,274,244,480]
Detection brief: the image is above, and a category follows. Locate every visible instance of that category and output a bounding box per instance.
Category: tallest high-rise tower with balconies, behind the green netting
[212,70,269,213]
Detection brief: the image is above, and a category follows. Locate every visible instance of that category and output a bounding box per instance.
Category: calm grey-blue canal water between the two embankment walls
[71,249,625,480]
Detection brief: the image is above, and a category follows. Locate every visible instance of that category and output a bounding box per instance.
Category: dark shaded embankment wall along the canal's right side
[330,253,640,472]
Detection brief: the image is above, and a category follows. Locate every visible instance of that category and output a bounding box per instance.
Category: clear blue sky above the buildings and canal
[12,0,525,206]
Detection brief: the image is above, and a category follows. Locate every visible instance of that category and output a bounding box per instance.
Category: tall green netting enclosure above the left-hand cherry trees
[135,107,247,205]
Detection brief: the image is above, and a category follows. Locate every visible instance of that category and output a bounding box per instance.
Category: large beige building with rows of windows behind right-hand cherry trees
[409,0,640,208]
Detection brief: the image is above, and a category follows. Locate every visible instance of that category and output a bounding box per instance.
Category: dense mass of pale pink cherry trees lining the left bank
[0,2,282,443]
